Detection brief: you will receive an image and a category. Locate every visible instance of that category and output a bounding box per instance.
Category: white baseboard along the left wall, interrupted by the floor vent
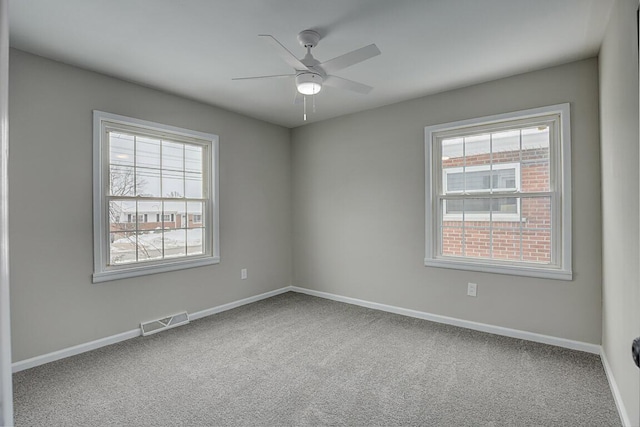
[11,286,291,372]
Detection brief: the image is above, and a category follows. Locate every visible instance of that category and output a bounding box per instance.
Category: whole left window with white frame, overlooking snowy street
[93,111,219,282]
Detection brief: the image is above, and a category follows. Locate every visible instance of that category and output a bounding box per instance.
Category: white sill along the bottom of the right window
[424,258,573,281]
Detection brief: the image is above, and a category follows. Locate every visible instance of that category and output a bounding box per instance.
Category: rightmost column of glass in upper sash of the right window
[521,126,550,192]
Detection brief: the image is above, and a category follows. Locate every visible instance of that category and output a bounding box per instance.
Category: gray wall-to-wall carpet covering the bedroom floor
[14,293,621,427]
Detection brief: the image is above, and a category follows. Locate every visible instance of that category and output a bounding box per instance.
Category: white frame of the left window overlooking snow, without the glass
[93,110,220,283]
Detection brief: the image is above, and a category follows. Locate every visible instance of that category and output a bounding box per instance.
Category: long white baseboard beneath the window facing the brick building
[290,286,600,354]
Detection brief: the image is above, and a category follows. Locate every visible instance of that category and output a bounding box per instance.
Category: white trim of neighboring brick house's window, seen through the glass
[442,163,526,222]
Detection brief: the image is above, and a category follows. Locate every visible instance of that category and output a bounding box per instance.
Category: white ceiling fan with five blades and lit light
[233,30,380,120]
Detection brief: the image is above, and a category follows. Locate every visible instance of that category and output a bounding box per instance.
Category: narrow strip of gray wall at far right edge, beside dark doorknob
[599,0,640,425]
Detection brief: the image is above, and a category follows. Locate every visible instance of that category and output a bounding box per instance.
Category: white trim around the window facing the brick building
[424,103,573,280]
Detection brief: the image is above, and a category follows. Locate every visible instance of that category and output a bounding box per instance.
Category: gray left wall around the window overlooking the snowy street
[9,50,292,361]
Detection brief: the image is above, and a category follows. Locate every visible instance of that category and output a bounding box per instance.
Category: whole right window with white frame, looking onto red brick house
[425,104,572,280]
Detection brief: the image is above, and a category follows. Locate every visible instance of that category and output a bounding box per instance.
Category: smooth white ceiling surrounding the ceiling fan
[9,0,613,127]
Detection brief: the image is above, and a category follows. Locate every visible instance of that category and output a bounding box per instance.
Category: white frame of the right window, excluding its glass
[424,103,573,280]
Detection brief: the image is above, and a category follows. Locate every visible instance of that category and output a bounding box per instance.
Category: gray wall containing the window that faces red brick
[292,59,604,344]
